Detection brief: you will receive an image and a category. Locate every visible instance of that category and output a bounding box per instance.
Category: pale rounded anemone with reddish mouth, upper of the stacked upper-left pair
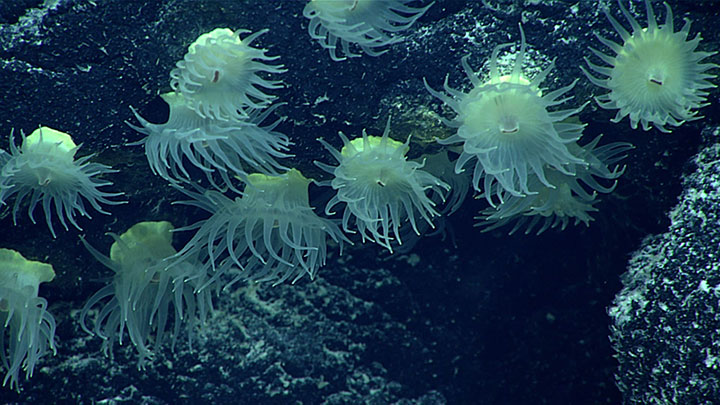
[170,28,285,120]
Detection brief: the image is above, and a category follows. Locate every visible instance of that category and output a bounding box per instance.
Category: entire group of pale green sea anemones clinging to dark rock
[0,0,717,388]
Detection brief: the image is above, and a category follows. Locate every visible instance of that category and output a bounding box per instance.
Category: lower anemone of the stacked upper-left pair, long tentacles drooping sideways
[129,92,290,189]
